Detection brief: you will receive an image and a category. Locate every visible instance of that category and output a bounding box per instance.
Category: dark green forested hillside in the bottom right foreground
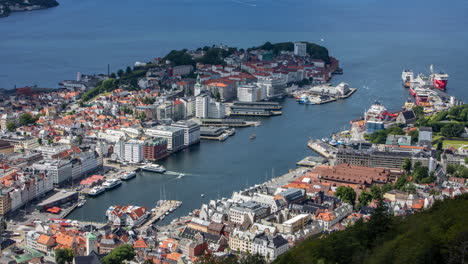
[274,194,468,264]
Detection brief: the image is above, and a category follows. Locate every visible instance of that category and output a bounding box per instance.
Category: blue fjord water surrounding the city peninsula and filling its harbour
[0,0,468,221]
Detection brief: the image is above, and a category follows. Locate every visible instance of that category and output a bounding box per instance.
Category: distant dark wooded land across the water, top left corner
[0,0,59,18]
